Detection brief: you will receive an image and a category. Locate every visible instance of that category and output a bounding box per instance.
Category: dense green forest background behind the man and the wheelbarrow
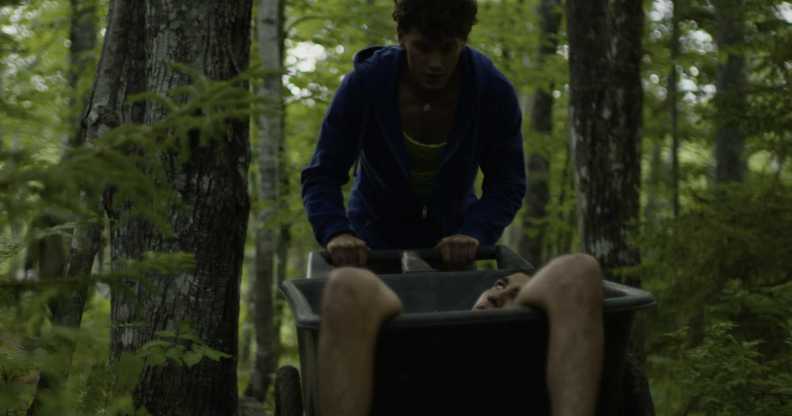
[0,0,792,415]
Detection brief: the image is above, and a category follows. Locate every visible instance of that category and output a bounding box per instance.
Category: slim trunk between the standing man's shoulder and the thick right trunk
[519,0,561,265]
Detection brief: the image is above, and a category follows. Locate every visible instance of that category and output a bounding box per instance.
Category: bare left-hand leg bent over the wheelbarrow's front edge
[319,268,401,416]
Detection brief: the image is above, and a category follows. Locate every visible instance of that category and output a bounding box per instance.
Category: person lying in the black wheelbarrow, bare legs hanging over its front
[318,254,604,416]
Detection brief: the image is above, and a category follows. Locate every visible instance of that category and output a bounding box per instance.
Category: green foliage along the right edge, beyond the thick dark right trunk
[640,11,792,415]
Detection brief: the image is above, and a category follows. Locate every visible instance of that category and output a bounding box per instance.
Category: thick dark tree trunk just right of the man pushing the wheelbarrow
[567,0,654,415]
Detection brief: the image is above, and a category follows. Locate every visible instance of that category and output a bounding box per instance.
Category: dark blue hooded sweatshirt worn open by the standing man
[301,47,525,249]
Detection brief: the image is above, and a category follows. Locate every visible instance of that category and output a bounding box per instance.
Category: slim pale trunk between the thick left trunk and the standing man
[245,0,283,402]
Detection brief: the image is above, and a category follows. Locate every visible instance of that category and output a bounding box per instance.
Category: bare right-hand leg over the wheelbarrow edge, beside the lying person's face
[517,254,604,416]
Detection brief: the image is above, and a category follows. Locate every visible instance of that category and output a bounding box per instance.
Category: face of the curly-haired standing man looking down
[399,30,465,90]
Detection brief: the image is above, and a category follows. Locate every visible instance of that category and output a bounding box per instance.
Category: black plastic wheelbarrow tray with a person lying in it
[277,246,655,416]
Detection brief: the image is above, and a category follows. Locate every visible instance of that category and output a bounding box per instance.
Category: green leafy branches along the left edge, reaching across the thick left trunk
[0,6,266,416]
